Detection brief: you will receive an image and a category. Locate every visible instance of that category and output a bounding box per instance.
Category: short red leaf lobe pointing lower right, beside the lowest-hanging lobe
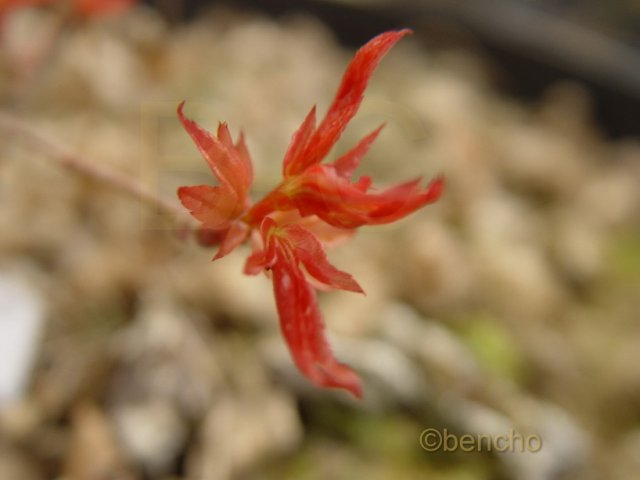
[282,224,364,293]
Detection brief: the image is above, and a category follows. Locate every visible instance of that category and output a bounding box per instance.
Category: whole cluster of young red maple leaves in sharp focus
[178,29,444,398]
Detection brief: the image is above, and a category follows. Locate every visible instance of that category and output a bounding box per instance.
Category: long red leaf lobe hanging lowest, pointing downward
[273,243,362,398]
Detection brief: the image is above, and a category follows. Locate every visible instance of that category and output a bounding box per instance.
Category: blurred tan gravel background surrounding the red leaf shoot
[0,0,640,480]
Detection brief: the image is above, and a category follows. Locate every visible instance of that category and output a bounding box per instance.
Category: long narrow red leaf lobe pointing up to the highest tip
[285,29,411,176]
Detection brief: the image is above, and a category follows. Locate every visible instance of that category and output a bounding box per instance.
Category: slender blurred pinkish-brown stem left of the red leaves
[0,112,197,229]
